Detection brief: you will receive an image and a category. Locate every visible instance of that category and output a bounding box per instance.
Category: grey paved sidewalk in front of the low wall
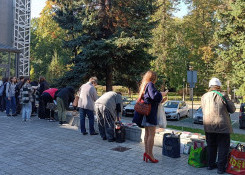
[0,113,226,175]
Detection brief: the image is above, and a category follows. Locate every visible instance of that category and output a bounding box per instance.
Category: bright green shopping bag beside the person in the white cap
[188,146,208,168]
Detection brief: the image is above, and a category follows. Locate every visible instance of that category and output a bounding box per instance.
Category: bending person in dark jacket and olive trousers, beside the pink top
[56,87,75,125]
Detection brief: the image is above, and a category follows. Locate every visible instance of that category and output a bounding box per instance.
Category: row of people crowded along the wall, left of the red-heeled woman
[0,77,123,142]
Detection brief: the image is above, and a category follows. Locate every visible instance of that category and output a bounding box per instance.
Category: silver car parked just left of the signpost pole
[163,100,189,120]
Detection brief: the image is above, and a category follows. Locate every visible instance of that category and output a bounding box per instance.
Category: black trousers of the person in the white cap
[205,132,230,171]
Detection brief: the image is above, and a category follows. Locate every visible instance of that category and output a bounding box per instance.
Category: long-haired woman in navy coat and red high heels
[133,70,166,163]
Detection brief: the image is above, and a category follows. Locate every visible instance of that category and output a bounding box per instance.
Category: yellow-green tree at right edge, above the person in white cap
[215,0,245,96]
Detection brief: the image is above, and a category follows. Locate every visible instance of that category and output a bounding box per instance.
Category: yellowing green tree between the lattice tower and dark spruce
[31,1,70,81]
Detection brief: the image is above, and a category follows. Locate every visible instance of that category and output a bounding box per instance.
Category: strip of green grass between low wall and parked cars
[167,125,245,142]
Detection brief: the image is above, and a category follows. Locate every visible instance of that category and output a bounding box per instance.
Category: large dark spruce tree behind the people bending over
[55,0,157,91]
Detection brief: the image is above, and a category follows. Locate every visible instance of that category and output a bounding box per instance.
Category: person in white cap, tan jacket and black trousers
[201,78,236,174]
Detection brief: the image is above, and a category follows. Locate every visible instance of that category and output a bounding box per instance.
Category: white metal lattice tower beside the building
[14,0,31,76]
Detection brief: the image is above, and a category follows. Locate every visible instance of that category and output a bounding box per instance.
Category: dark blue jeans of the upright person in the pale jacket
[79,108,95,134]
